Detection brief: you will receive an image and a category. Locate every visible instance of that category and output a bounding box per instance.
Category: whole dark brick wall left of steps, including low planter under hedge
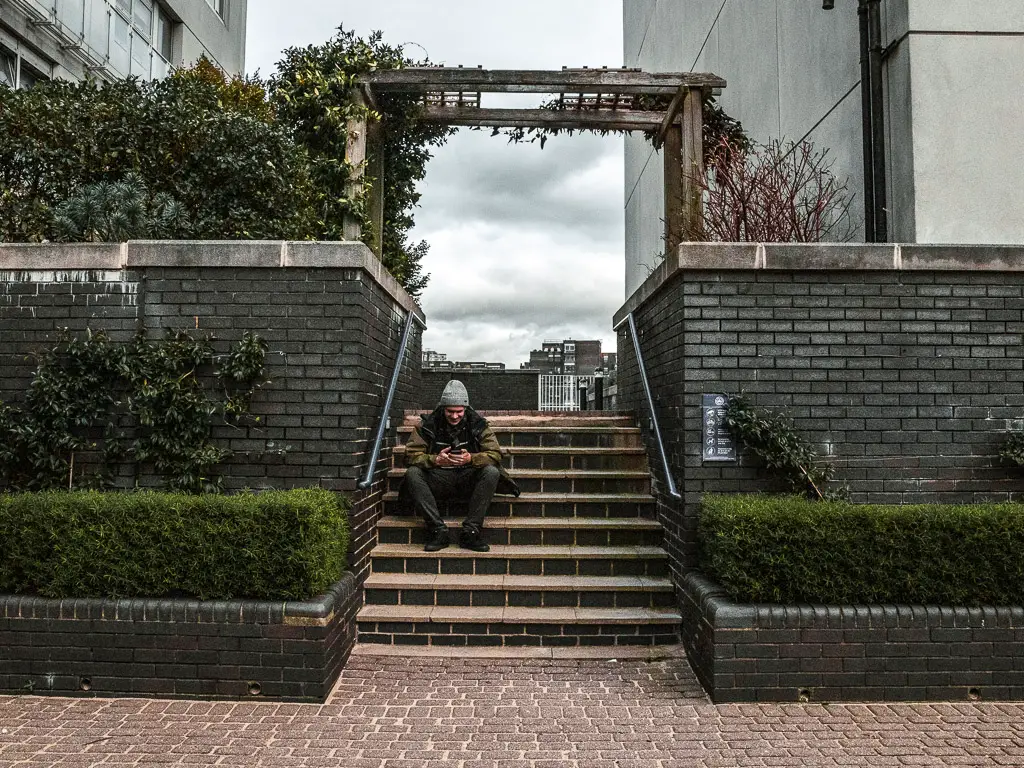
[0,242,423,700]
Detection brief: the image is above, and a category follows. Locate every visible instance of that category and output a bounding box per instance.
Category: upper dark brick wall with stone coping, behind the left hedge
[0,243,421,501]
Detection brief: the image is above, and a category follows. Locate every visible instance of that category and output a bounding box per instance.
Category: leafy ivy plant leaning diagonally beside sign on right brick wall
[724,396,842,499]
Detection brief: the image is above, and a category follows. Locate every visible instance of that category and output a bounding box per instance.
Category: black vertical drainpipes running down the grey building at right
[821,0,889,243]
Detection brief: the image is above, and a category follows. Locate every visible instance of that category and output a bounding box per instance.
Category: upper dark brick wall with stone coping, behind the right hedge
[616,245,1024,583]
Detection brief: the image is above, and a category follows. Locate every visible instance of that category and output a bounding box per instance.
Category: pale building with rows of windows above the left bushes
[0,0,248,88]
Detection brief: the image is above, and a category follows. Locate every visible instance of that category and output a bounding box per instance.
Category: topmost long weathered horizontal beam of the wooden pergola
[361,67,725,96]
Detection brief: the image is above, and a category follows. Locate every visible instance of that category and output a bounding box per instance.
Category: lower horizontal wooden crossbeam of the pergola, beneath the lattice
[420,105,662,131]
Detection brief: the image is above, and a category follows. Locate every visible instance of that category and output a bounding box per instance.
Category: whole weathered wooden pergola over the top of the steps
[345,67,725,255]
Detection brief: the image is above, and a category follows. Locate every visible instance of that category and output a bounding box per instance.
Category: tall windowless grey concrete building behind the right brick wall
[623,0,1024,296]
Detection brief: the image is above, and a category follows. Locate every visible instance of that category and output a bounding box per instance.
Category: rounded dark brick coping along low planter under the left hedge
[0,572,356,627]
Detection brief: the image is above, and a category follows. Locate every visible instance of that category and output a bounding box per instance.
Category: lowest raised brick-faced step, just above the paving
[356,605,682,646]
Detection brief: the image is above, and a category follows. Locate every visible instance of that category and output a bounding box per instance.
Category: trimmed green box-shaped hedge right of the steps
[697,495,1024,606]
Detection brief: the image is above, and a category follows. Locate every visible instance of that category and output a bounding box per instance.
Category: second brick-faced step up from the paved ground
[364,573,676,608]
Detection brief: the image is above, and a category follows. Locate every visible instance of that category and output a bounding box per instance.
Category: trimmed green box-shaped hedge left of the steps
[0,488,348,600]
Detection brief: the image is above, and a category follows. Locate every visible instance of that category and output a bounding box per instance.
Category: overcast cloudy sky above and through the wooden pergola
[246,0,625,368]
